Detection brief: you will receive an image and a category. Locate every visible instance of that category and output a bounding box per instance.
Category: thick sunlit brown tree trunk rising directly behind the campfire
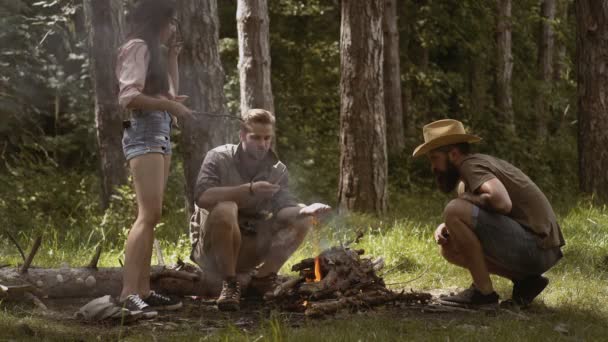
[338,0,387,214]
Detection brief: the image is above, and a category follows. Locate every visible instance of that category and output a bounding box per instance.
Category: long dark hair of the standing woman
[127,0,176,95]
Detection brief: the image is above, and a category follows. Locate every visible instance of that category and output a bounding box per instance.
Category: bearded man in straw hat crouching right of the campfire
[414,119,564,307]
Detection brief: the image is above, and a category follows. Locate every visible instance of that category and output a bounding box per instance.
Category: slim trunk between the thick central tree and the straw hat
[383,0,405,154]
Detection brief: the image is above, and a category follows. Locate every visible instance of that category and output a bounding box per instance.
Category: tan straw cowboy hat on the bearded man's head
[413,119,481,157]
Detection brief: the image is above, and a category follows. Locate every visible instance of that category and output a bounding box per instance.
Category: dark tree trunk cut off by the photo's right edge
[576,0,608,201]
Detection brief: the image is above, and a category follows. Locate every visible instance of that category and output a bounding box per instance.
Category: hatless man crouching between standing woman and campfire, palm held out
[190,109,330,310]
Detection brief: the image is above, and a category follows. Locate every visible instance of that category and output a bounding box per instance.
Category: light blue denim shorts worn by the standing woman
[122,111,172,160]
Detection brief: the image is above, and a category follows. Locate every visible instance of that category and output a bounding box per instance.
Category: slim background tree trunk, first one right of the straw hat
[496,0,515,133]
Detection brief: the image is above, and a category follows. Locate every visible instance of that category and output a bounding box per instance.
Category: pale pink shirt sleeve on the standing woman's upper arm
[116,39,150,108]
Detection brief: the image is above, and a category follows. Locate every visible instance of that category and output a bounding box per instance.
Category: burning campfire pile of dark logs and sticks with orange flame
[266,246,432,317]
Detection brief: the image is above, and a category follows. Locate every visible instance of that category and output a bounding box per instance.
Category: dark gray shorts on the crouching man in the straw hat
[473,206,562,276]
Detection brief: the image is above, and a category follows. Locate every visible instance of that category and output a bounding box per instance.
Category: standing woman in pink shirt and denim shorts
[116,0,192,317]
